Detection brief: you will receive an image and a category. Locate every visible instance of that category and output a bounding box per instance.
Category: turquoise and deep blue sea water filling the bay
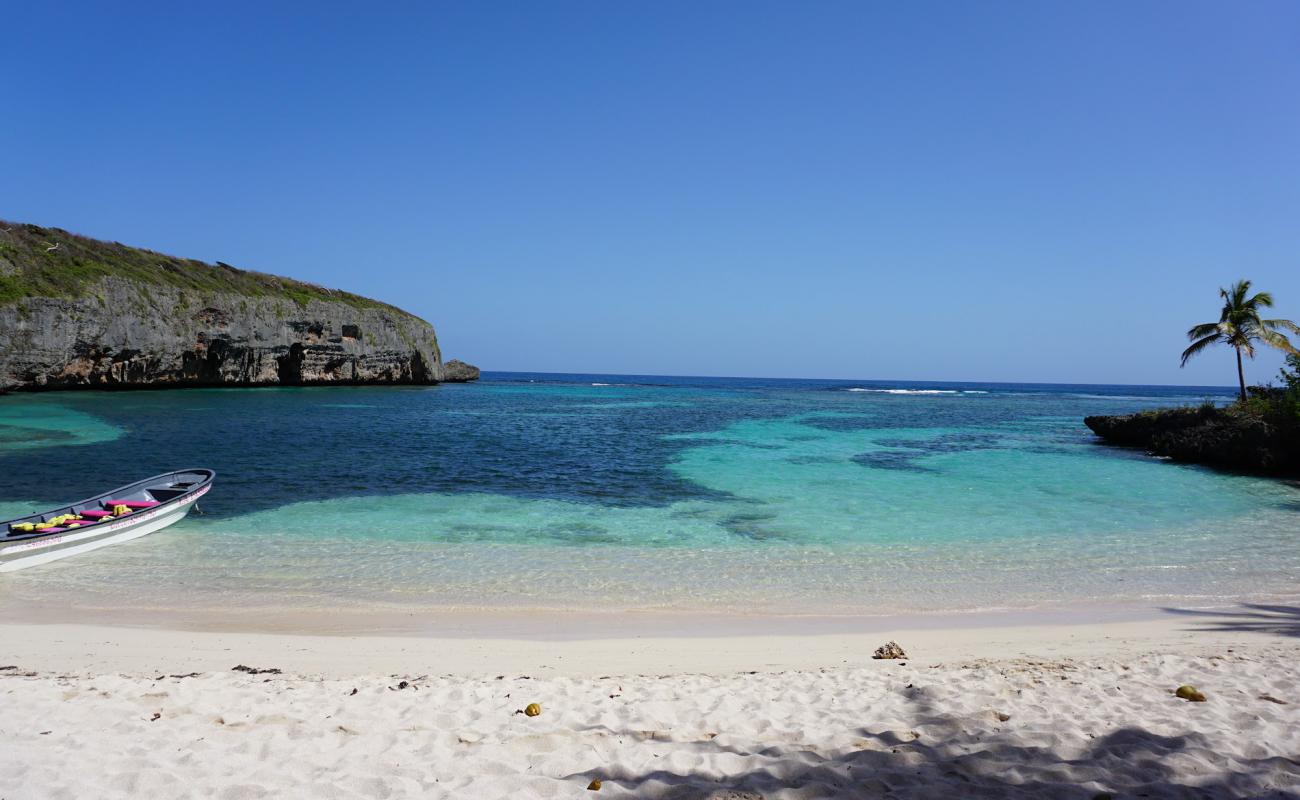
[0,373,1300,615]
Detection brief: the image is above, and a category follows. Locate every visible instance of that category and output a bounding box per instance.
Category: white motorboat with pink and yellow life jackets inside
[0,470,217,572]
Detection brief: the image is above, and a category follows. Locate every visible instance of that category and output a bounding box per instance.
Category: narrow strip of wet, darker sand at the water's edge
[0,583,1300,640]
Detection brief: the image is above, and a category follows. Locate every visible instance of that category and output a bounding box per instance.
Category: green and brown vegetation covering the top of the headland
[0,220,411,316]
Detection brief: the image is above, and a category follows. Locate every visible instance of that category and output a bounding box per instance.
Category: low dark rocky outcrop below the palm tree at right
[1083,406,1300,475]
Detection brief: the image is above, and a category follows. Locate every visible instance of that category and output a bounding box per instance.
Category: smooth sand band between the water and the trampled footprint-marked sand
[0,605,1300,676]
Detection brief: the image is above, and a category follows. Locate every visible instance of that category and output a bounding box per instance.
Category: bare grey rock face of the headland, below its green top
[0,284,441,389]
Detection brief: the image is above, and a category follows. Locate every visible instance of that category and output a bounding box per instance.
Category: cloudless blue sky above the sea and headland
[0,0,1300,385]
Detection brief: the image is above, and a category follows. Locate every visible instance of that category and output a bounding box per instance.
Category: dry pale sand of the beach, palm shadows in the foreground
[0,609,1300,800]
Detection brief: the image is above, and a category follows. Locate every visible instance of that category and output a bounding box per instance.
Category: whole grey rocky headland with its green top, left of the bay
[0,222,477,389]
